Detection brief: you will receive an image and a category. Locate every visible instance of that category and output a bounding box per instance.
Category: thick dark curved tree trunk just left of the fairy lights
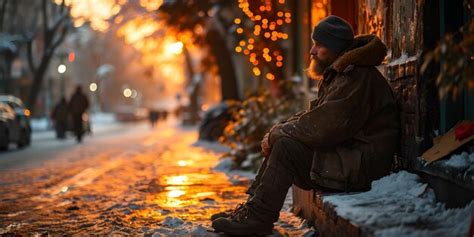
[206,29,240,101]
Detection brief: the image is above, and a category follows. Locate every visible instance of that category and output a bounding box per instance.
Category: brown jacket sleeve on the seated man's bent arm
[269,76,370,147]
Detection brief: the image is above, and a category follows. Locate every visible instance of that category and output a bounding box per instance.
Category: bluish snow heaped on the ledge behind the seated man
[323,171,474,237]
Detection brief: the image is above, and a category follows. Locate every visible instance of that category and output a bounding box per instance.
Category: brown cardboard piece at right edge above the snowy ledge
[421,121,474,164]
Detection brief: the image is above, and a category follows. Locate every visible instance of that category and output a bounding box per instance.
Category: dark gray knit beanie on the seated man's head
[311,16,354,54]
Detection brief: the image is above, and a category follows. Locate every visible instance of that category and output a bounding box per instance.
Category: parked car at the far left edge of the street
[0,95,31,147]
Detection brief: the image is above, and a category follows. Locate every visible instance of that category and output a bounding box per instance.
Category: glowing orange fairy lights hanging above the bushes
[234,0,291,80]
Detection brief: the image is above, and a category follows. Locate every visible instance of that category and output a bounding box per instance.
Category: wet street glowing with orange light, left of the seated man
[0,121,252,235]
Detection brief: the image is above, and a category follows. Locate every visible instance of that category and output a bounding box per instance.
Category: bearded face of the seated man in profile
[308,41,337,79]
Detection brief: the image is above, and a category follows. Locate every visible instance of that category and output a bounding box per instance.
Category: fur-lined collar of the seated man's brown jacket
[332,35,387,72]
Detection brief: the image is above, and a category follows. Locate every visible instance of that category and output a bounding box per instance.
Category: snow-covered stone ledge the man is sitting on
[293,171,474,237]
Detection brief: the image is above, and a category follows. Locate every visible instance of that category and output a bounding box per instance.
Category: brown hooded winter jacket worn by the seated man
[269,35,399,191]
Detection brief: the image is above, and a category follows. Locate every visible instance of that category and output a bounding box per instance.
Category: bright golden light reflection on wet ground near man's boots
[133,134,250,221]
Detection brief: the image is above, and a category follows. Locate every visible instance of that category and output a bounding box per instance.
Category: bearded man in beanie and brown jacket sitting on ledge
[211,16,399,235]
